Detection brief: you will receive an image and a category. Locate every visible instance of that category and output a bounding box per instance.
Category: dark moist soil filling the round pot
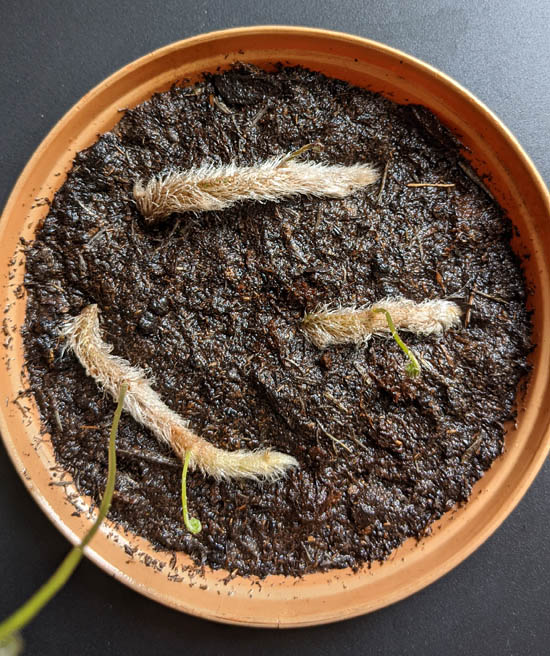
[24,67,530,576]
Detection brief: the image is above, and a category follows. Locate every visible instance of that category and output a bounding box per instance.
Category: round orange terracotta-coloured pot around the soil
[0,27,550,627]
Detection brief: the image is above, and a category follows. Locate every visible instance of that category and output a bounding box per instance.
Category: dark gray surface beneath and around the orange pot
[0,0,550,656]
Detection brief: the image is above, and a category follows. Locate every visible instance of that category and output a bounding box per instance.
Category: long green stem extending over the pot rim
[0,384,128,644]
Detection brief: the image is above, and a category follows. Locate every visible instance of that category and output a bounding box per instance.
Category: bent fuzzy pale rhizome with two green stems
[62,305,298,480]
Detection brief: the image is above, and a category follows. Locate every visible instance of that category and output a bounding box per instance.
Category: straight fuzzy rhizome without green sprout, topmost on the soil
[134,154,380,223]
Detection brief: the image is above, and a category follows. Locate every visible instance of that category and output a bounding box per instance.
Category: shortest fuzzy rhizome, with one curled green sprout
[302,298,462,349]
